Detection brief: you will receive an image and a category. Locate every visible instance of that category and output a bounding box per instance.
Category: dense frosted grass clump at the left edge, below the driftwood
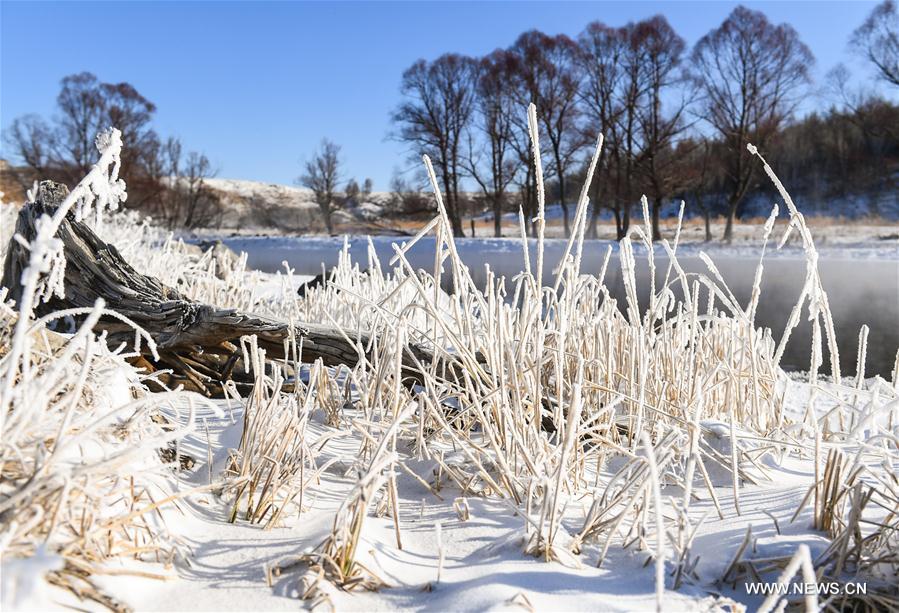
[0,130,229,610]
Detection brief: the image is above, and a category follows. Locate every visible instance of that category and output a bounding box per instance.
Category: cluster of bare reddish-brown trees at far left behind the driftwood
[4,72,223,228]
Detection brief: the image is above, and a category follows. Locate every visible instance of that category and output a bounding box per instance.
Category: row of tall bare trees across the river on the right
[391,0,899,240]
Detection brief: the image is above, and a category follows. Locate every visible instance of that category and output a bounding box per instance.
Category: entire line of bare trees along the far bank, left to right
[4,0,899,239]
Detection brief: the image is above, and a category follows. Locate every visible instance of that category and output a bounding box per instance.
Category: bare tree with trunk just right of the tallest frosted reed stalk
[509,30,583,236]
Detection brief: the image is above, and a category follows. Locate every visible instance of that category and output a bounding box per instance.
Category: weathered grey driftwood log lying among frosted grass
[2,181,458,395]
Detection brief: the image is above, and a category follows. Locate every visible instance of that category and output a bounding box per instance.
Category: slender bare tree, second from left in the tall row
[464,50,516,236]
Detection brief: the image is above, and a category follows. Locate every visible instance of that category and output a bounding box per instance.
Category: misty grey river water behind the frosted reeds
[223,237,899,379]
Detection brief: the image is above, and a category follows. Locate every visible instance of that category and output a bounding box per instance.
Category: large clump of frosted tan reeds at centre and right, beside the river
[286,108,897,601]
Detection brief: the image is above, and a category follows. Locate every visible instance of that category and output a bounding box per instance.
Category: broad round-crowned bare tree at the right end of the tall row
[692,6,814,241]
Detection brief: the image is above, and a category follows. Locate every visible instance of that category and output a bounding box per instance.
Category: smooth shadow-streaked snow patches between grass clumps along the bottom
[47,383,884,611]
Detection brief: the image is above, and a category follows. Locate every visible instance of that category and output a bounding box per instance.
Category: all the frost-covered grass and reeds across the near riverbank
[0,116,899,610]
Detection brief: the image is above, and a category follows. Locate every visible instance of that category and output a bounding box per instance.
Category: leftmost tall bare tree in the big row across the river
[391,54,476,236]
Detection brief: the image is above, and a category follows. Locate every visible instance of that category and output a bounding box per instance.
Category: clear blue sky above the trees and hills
[0,0,875,189]
